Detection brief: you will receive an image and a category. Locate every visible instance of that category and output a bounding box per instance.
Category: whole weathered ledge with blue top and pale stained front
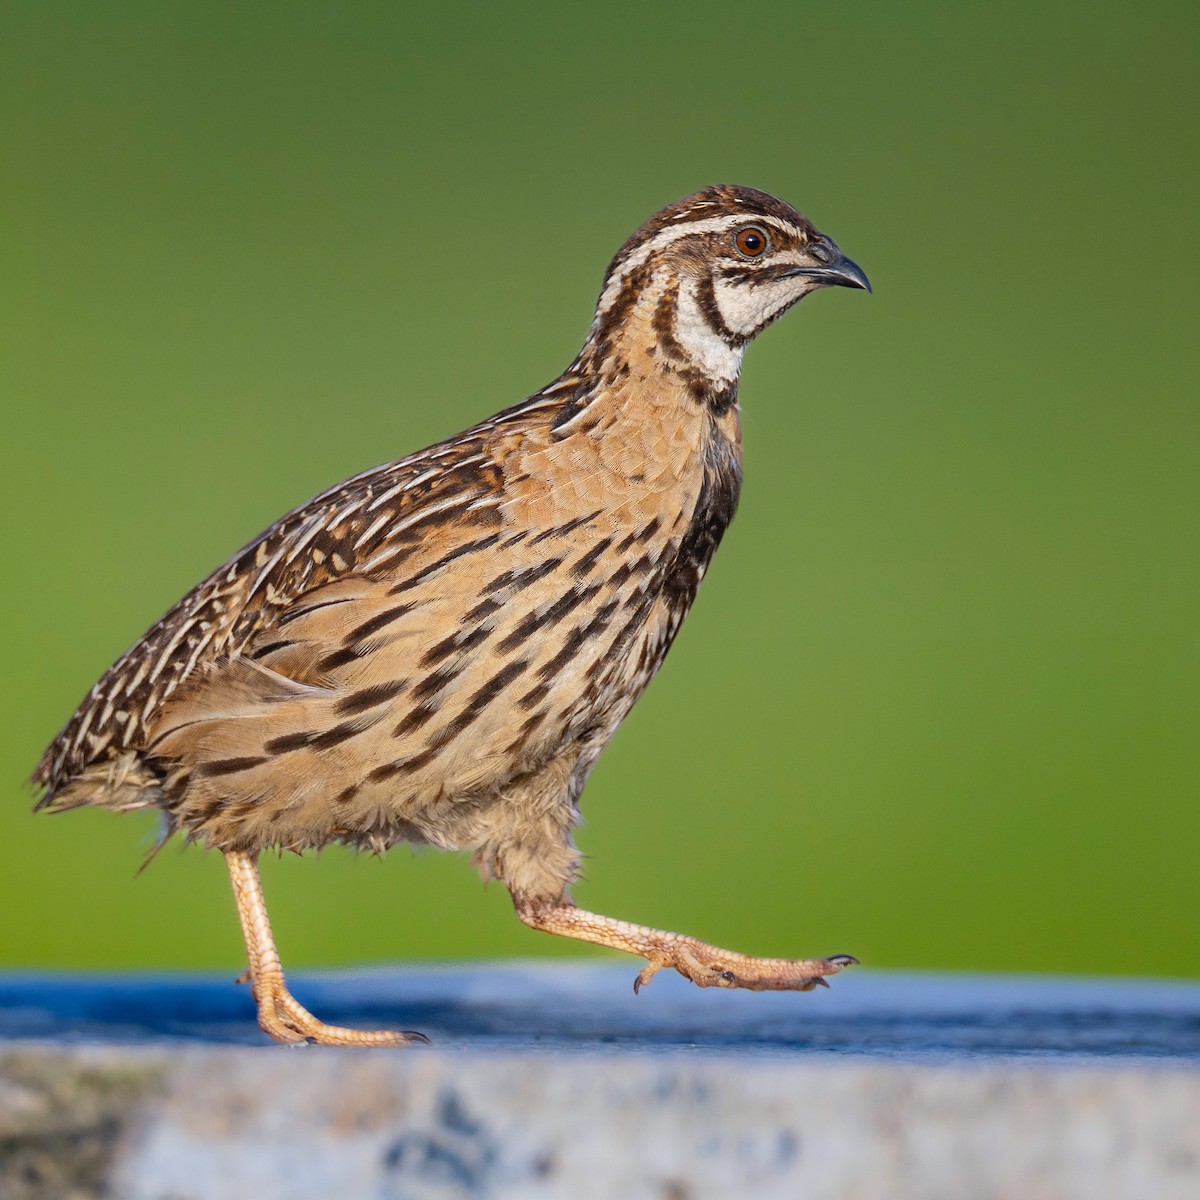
[0,965,1200,1200]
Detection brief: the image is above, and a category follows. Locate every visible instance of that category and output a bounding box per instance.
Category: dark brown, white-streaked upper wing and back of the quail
[32,426,503,804]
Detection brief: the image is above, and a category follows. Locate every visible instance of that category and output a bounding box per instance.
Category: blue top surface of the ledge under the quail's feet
[0,962,1200,1064]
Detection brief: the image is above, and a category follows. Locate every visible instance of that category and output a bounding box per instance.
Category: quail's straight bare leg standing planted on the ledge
[226,851,428,1046]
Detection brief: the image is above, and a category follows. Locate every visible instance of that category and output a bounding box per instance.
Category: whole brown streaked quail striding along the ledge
[34,186,868,1045]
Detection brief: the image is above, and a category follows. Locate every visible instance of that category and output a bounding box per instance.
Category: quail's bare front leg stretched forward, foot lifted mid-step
[514,896,858,991]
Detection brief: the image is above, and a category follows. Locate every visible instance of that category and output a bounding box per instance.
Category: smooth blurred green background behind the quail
[0,0,1200,976]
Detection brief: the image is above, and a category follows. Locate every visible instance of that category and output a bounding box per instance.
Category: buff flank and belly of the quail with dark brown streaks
[152,528,668,851]
